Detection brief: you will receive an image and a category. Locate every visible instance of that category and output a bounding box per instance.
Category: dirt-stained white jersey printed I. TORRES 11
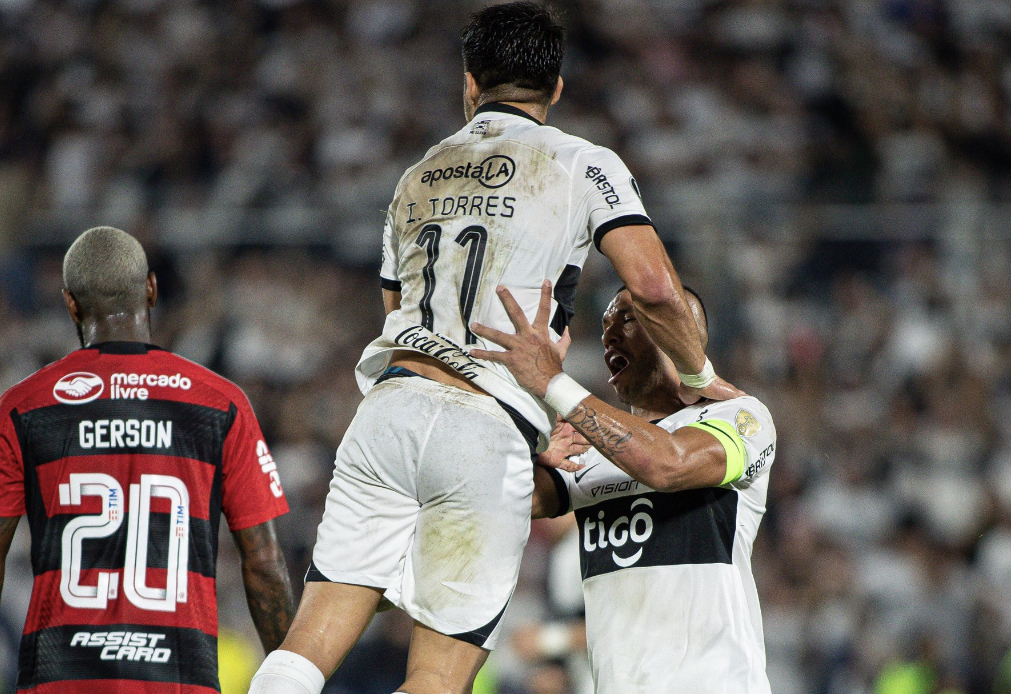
[357,103,651,435]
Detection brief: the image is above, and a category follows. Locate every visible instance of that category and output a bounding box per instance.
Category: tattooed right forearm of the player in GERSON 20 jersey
[232,521,295,653]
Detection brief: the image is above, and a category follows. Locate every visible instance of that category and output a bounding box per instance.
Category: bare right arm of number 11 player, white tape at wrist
[601,225,743,403]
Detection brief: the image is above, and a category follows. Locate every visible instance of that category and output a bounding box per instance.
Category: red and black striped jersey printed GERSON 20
[0,342,288,694]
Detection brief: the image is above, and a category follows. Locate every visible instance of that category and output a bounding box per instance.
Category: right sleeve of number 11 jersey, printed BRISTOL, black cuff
[572,147,653,250]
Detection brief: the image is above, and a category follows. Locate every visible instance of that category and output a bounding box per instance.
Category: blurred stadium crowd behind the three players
[0,0,1011,694]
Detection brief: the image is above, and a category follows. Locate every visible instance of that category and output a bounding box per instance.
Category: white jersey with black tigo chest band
[552,397,775,694]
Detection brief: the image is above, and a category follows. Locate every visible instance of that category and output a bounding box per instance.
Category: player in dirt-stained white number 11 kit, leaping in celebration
[251,3,738,694]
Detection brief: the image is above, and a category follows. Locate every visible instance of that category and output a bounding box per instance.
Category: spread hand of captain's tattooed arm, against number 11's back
[470,280,569,398]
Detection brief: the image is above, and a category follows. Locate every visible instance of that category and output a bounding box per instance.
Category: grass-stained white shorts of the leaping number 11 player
[306,376,534,649]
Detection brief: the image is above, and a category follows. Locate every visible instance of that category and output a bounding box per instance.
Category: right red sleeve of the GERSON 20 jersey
[221,393,288,531]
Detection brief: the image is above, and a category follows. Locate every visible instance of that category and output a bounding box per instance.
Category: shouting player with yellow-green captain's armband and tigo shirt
[474,289,775,694]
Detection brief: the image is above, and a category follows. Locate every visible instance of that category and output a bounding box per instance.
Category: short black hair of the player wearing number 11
[462,2,565,99]
